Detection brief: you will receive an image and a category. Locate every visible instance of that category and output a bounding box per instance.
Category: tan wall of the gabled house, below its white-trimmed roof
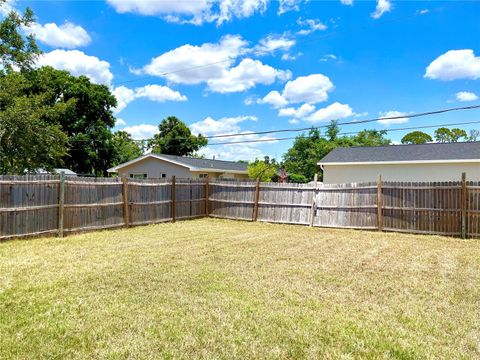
[118,158,248,179]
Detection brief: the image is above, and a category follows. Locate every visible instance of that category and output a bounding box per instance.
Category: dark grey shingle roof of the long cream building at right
[318,142,480,165]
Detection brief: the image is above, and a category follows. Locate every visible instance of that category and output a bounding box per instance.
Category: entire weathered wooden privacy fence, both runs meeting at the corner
[0,175,480,239]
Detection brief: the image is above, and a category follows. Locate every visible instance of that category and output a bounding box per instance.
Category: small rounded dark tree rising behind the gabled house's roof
[148,116,208,156]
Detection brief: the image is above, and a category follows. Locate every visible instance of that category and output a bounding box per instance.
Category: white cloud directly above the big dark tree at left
[37,50,113,85]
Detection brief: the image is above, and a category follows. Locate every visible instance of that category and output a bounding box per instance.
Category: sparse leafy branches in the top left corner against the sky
[0,0,41,73]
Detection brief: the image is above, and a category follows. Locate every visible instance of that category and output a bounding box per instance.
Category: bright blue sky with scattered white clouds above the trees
[9,0,480,160]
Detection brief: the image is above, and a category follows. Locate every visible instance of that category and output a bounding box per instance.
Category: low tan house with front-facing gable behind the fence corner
[107,154,248,179]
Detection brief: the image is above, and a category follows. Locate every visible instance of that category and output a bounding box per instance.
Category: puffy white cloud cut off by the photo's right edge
[425,49,480,81]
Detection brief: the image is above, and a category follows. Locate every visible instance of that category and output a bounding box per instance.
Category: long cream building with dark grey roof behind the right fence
[318,142,480,184]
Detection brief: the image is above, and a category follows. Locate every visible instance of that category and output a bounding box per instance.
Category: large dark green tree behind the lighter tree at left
[26,66,117,176]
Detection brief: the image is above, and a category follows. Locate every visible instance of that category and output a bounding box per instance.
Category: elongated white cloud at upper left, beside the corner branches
[25,21,92,49]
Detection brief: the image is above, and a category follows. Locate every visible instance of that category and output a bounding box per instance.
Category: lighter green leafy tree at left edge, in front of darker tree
[0,72,68,174]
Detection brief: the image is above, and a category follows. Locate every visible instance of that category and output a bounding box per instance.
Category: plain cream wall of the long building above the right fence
[323,162,480,184]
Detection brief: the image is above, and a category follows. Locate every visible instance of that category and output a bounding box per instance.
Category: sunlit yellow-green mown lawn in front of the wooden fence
[0,219,480,359]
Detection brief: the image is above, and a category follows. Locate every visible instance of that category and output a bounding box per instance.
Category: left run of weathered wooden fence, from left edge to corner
[0,175,206,239]
